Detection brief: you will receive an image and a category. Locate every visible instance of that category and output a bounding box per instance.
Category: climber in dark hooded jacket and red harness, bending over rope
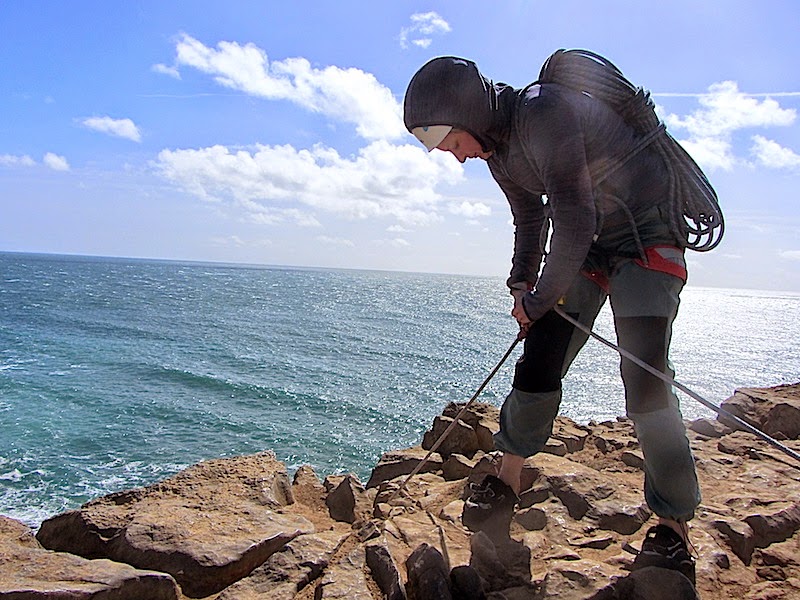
[404,51,700,582]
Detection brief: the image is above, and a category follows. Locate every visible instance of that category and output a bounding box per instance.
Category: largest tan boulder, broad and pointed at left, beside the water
[37,453,314,598]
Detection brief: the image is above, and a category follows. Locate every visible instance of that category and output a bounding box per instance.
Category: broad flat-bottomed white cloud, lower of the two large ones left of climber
[156,141,463,224]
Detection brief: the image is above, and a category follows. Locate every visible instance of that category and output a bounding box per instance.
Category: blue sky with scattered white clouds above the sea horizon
[0,0,800,291]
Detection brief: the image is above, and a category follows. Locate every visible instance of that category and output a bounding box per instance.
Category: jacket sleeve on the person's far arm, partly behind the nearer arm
[490,164,545,291]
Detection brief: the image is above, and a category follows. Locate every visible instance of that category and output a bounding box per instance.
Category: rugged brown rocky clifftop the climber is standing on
[0,384,800,600]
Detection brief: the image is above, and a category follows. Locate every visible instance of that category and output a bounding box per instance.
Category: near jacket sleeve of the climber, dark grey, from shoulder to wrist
[518,88,597,321]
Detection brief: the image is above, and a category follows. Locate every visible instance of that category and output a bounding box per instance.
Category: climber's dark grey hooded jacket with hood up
[404,57,678,320]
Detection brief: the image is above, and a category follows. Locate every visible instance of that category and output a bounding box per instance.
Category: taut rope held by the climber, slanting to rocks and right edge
[387,306,800,504]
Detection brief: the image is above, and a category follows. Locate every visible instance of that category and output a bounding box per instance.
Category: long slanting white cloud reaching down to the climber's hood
[171,34,407,140]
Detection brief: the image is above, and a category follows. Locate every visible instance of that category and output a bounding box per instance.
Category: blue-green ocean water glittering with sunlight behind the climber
[0,253,800,526]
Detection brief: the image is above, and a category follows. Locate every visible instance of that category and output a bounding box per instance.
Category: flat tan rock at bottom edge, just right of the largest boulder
[216,531,347,600]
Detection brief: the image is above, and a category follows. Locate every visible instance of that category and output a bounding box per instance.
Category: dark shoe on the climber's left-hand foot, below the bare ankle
[461,475,518,537]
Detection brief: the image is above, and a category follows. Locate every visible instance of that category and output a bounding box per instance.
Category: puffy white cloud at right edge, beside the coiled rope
[664,81,797,170]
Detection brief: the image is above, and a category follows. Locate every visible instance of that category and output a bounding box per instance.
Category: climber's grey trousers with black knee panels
[494,259,700,521]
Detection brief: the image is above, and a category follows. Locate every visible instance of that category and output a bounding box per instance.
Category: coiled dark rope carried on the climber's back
[537,49,725,252]
